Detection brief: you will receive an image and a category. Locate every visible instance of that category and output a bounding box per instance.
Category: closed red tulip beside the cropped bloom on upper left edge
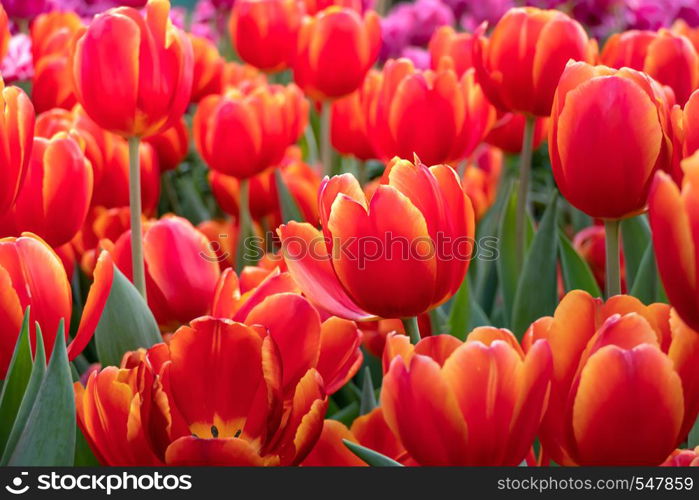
[2,132,93,247]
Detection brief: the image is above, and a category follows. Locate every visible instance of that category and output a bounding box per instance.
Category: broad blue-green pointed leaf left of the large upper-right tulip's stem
[511,195,558,337]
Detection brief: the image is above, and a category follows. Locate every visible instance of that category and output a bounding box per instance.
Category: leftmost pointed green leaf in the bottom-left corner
[0,307,32,452]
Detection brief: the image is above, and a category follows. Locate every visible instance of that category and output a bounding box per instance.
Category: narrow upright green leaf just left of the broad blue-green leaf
[497,180,534,322]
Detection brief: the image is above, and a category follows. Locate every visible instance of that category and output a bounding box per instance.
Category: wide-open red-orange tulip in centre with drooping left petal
[278,159,474,320]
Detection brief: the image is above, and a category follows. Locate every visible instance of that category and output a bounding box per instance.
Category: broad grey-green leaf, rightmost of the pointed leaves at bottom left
[9,320,76,466]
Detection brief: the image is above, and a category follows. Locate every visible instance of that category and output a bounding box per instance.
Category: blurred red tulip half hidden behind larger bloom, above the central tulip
[330,70,381,161]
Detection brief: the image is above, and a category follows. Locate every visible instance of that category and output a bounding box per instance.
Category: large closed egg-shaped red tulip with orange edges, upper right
[549,63,672,219]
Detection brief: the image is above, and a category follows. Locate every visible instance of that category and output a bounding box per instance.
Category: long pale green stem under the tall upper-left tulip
[128,136,146,299]
